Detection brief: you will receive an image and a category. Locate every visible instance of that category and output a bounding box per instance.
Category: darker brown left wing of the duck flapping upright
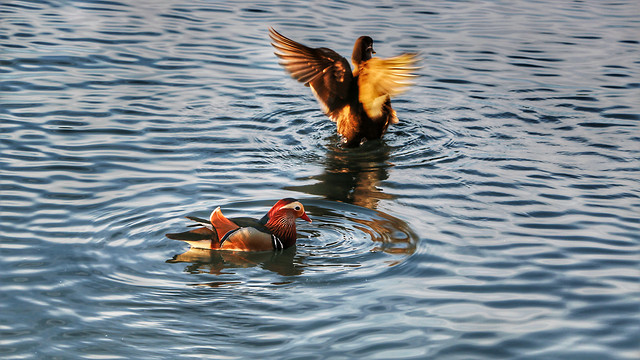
[269,28,353,113]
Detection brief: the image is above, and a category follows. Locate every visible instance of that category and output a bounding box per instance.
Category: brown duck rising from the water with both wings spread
[269,28,418,147]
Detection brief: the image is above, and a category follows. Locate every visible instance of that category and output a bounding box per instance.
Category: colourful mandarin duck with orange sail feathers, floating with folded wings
[167,198,311,251]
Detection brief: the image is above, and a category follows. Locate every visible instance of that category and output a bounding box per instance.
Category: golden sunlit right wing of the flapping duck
[358,53,418,119]
